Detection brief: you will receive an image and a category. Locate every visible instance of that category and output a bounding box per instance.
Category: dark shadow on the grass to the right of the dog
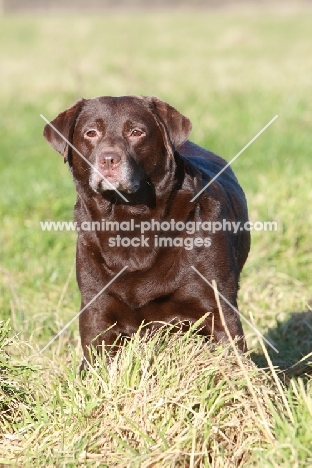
[251,310,312,375]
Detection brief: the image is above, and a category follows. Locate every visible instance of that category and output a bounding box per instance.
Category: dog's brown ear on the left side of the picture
[43,99,85,163]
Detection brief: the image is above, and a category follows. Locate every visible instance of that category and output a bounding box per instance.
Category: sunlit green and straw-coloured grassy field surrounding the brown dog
[0,8,312,468]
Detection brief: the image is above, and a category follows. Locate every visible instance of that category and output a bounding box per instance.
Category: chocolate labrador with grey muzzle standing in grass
[44,96,250,361]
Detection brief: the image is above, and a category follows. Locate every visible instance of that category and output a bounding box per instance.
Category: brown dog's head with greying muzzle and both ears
[44,96,191,194]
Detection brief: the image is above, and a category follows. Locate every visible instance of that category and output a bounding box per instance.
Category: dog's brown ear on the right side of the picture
[145,97,192,152]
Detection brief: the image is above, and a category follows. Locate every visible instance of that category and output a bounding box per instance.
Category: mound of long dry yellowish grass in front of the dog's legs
[2,326,279,468]
